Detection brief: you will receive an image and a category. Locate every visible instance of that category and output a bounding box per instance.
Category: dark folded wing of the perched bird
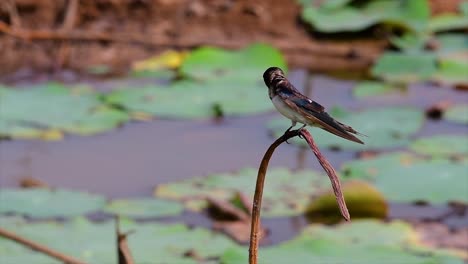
[276,83,364,144]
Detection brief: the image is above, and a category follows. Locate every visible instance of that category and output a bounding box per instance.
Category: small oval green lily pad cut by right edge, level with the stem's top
[411,135,468,157]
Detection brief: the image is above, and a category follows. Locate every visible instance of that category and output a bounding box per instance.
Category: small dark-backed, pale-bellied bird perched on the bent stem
[263,67,364,144]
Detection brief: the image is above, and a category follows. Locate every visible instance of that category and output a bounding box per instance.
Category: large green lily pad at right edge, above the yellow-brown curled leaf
[343,153,468,204]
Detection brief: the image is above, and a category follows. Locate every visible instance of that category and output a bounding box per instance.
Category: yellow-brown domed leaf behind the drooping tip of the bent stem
[306,180,388,221]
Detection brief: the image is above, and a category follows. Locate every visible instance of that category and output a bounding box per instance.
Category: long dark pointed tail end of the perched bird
[313,112,367,145]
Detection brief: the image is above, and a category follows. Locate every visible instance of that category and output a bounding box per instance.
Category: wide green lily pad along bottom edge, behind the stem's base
[221,220,463,264]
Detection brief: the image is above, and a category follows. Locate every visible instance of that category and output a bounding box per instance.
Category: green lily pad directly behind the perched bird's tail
[268,107,424,150]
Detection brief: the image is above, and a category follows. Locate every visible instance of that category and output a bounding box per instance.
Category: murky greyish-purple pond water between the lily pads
[0,70,468,242]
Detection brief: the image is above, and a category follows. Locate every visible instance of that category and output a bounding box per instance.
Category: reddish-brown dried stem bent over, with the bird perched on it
[249,129,350,264]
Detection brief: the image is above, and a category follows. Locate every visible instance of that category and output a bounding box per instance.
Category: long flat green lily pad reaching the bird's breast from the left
[106,76,273,118]
